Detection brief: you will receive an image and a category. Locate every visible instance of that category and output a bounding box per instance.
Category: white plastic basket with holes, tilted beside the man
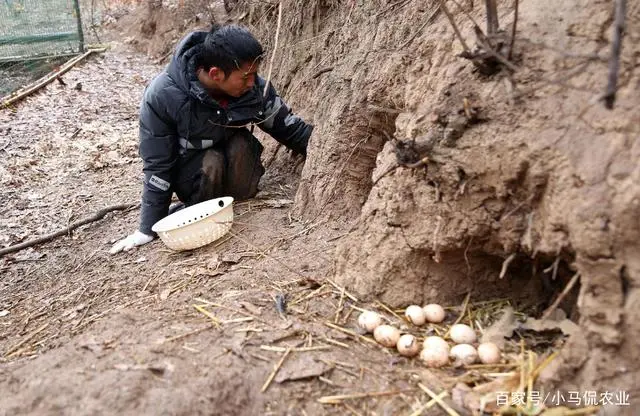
[151,196,233,251]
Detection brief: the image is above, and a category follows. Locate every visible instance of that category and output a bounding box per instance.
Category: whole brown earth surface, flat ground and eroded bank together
[0,0,640,415]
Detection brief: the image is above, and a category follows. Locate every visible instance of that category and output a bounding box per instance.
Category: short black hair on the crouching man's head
[198,24,264,76]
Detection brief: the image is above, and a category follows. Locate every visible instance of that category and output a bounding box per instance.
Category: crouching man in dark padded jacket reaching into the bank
[110,25,313,254]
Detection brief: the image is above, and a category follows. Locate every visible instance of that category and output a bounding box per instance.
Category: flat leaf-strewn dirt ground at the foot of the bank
[0,47,460,415]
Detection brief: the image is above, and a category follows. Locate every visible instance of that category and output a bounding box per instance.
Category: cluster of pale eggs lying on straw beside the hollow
[358,304,501,367]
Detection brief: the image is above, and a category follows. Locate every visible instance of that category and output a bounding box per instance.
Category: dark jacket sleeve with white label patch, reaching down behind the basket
[140,91,178,235]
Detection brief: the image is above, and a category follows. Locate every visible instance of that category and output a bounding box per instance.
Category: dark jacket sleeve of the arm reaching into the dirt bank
[258,85,313,156]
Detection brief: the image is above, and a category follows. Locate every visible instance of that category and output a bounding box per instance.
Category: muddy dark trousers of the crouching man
[174,129,264,206]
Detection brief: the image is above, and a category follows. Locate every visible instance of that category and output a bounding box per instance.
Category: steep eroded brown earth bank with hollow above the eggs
[2,0,640,409]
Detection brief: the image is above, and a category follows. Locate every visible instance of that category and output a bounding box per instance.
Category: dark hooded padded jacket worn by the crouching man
[140,32,313,235]
